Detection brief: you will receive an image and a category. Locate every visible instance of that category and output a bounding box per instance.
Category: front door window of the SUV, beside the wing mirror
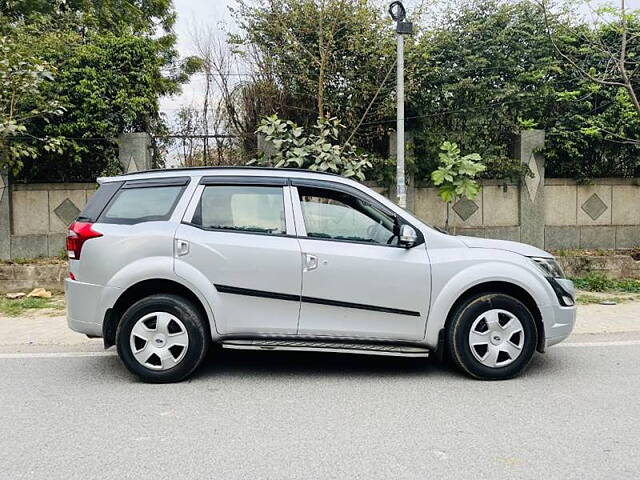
[298,186,397,245]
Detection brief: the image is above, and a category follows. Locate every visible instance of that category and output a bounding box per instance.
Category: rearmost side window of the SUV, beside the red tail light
[99,185,184,225]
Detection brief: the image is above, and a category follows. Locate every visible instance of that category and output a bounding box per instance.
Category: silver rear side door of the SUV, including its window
[176,176,302,335]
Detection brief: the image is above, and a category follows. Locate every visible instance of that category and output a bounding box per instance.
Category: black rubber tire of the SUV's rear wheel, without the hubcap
[116,294,210,383]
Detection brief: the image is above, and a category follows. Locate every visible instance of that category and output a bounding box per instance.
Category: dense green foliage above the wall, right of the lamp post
[407,0,640,179]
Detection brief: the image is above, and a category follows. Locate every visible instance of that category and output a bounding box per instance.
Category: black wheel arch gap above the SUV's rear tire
[102,278,213,348]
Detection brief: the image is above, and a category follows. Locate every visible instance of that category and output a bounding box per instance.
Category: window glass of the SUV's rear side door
[192,185,286,234]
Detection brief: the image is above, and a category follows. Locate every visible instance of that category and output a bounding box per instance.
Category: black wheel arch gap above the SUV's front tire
[437,281,545,357]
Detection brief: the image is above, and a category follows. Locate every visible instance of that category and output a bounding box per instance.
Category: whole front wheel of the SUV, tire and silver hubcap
[447,293,538,380]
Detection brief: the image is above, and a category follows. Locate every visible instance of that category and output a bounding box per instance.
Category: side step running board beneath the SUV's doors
[222,340,429,357]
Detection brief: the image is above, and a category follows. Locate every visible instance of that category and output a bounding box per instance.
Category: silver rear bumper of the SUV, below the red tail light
[64,278,121,337]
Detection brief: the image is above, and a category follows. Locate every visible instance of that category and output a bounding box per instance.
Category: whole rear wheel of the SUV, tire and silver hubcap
[116,294,209,383]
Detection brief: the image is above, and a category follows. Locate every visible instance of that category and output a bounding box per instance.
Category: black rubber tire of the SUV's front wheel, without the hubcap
[447,293,538,380]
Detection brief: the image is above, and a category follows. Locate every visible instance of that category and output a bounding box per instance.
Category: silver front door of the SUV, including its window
[292,181,430,340]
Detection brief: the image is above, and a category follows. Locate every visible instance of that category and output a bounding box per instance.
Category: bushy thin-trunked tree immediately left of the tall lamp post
[232,0,395,148]
